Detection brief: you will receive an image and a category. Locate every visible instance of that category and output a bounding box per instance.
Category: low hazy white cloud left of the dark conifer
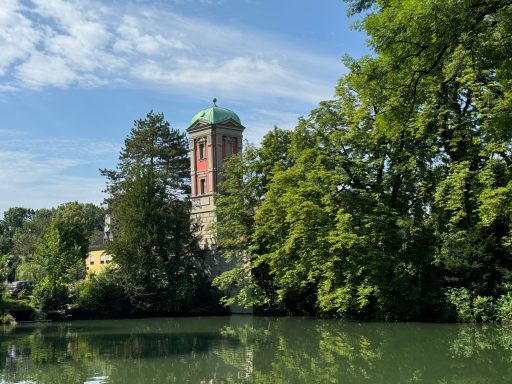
[0,130,118,214]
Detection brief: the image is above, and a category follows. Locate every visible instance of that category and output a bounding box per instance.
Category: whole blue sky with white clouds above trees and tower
[0,0,368,217]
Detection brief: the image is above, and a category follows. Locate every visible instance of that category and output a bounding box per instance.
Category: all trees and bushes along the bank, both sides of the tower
[0,0,512,322]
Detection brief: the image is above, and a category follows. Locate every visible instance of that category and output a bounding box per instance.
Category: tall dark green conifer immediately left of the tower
[102,112,204,312]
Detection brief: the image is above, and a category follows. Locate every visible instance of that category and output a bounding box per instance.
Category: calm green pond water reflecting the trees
[0,316,512,384]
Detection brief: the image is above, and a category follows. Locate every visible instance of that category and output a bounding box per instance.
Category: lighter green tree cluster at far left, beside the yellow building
[0,202,105,312]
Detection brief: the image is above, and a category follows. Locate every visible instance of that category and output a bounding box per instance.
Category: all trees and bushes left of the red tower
[0,112,218,317]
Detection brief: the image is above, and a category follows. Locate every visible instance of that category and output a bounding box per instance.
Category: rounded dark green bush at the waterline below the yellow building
[78,268,130,318]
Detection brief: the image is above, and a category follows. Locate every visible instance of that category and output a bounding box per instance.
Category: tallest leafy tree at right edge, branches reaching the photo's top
[344,0,512,316]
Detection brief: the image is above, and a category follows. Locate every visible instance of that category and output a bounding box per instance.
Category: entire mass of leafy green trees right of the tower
[216,0,512,321]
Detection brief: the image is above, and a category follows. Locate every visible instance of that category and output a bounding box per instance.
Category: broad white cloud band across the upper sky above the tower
[0,0,339,103]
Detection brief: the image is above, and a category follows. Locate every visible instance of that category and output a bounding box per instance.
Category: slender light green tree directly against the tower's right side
[213,144,270,307]
